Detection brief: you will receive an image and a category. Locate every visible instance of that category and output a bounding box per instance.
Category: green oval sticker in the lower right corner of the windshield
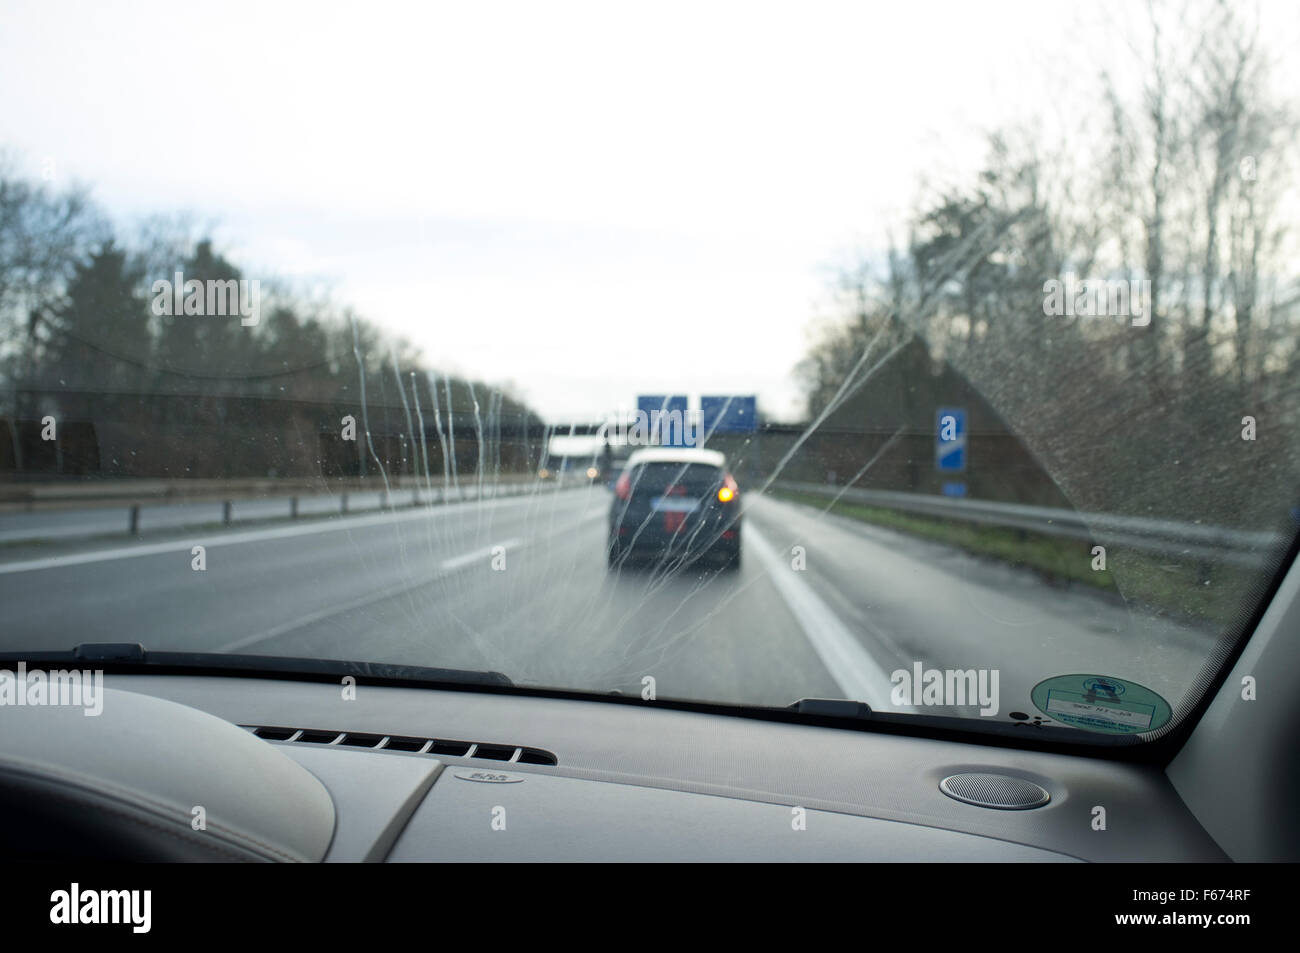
[1030,675,1173,735]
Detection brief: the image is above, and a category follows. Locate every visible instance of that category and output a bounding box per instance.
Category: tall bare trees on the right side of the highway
[797,0,1300,527]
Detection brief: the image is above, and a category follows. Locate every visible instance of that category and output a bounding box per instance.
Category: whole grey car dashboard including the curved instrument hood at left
[0,673,1227,862]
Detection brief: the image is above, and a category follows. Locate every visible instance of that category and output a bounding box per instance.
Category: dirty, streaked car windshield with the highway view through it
[0,0,1300,744]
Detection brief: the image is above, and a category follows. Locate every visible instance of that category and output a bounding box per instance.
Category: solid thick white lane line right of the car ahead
[745,523,891,711]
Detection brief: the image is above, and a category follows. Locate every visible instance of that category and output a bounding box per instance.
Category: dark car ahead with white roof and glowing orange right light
[608,447,741,568]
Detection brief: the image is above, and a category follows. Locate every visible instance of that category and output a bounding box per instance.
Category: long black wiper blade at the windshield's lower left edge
[0,642,515,688]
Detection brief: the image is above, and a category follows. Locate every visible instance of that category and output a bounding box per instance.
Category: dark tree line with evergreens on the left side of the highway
[0,164,542,477]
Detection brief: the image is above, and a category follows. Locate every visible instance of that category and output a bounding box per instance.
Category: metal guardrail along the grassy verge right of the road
[772,481,1290,566]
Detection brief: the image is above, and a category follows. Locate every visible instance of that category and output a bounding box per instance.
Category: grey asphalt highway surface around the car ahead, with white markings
[0,486,1214,720]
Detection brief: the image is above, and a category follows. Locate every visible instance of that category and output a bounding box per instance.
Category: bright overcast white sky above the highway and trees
[0,0,1294,420]
